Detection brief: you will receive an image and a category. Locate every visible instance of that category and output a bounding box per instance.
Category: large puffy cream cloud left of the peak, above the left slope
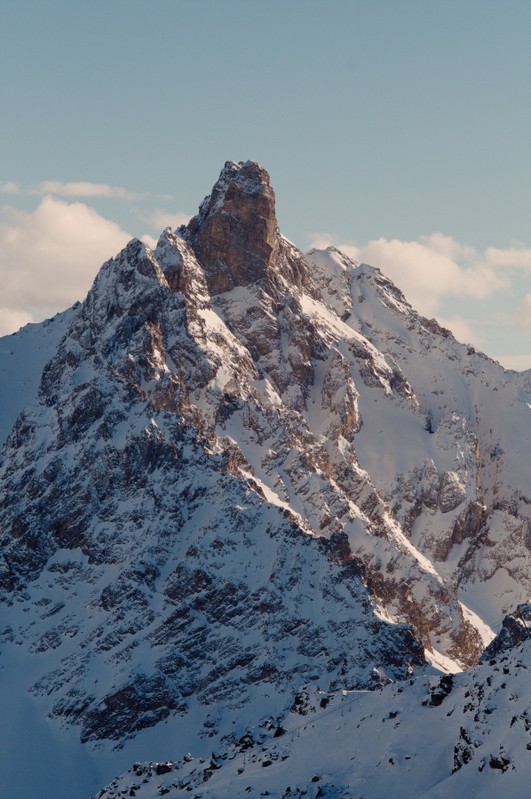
[0,196,131,333]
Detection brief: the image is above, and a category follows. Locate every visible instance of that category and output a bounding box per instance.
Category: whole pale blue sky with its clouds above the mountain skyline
[0,0,531,368]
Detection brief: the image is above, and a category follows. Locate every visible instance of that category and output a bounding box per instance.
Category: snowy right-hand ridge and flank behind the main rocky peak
[307,249,531,624]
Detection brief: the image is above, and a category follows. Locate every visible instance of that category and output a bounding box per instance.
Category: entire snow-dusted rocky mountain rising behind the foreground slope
[0,161,531,799]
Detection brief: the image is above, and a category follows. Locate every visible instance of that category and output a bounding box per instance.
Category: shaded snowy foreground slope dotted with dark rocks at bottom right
[93,638,531,799]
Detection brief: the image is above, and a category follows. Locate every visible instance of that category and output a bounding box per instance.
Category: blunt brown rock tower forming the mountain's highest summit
[183,161,279,294]
